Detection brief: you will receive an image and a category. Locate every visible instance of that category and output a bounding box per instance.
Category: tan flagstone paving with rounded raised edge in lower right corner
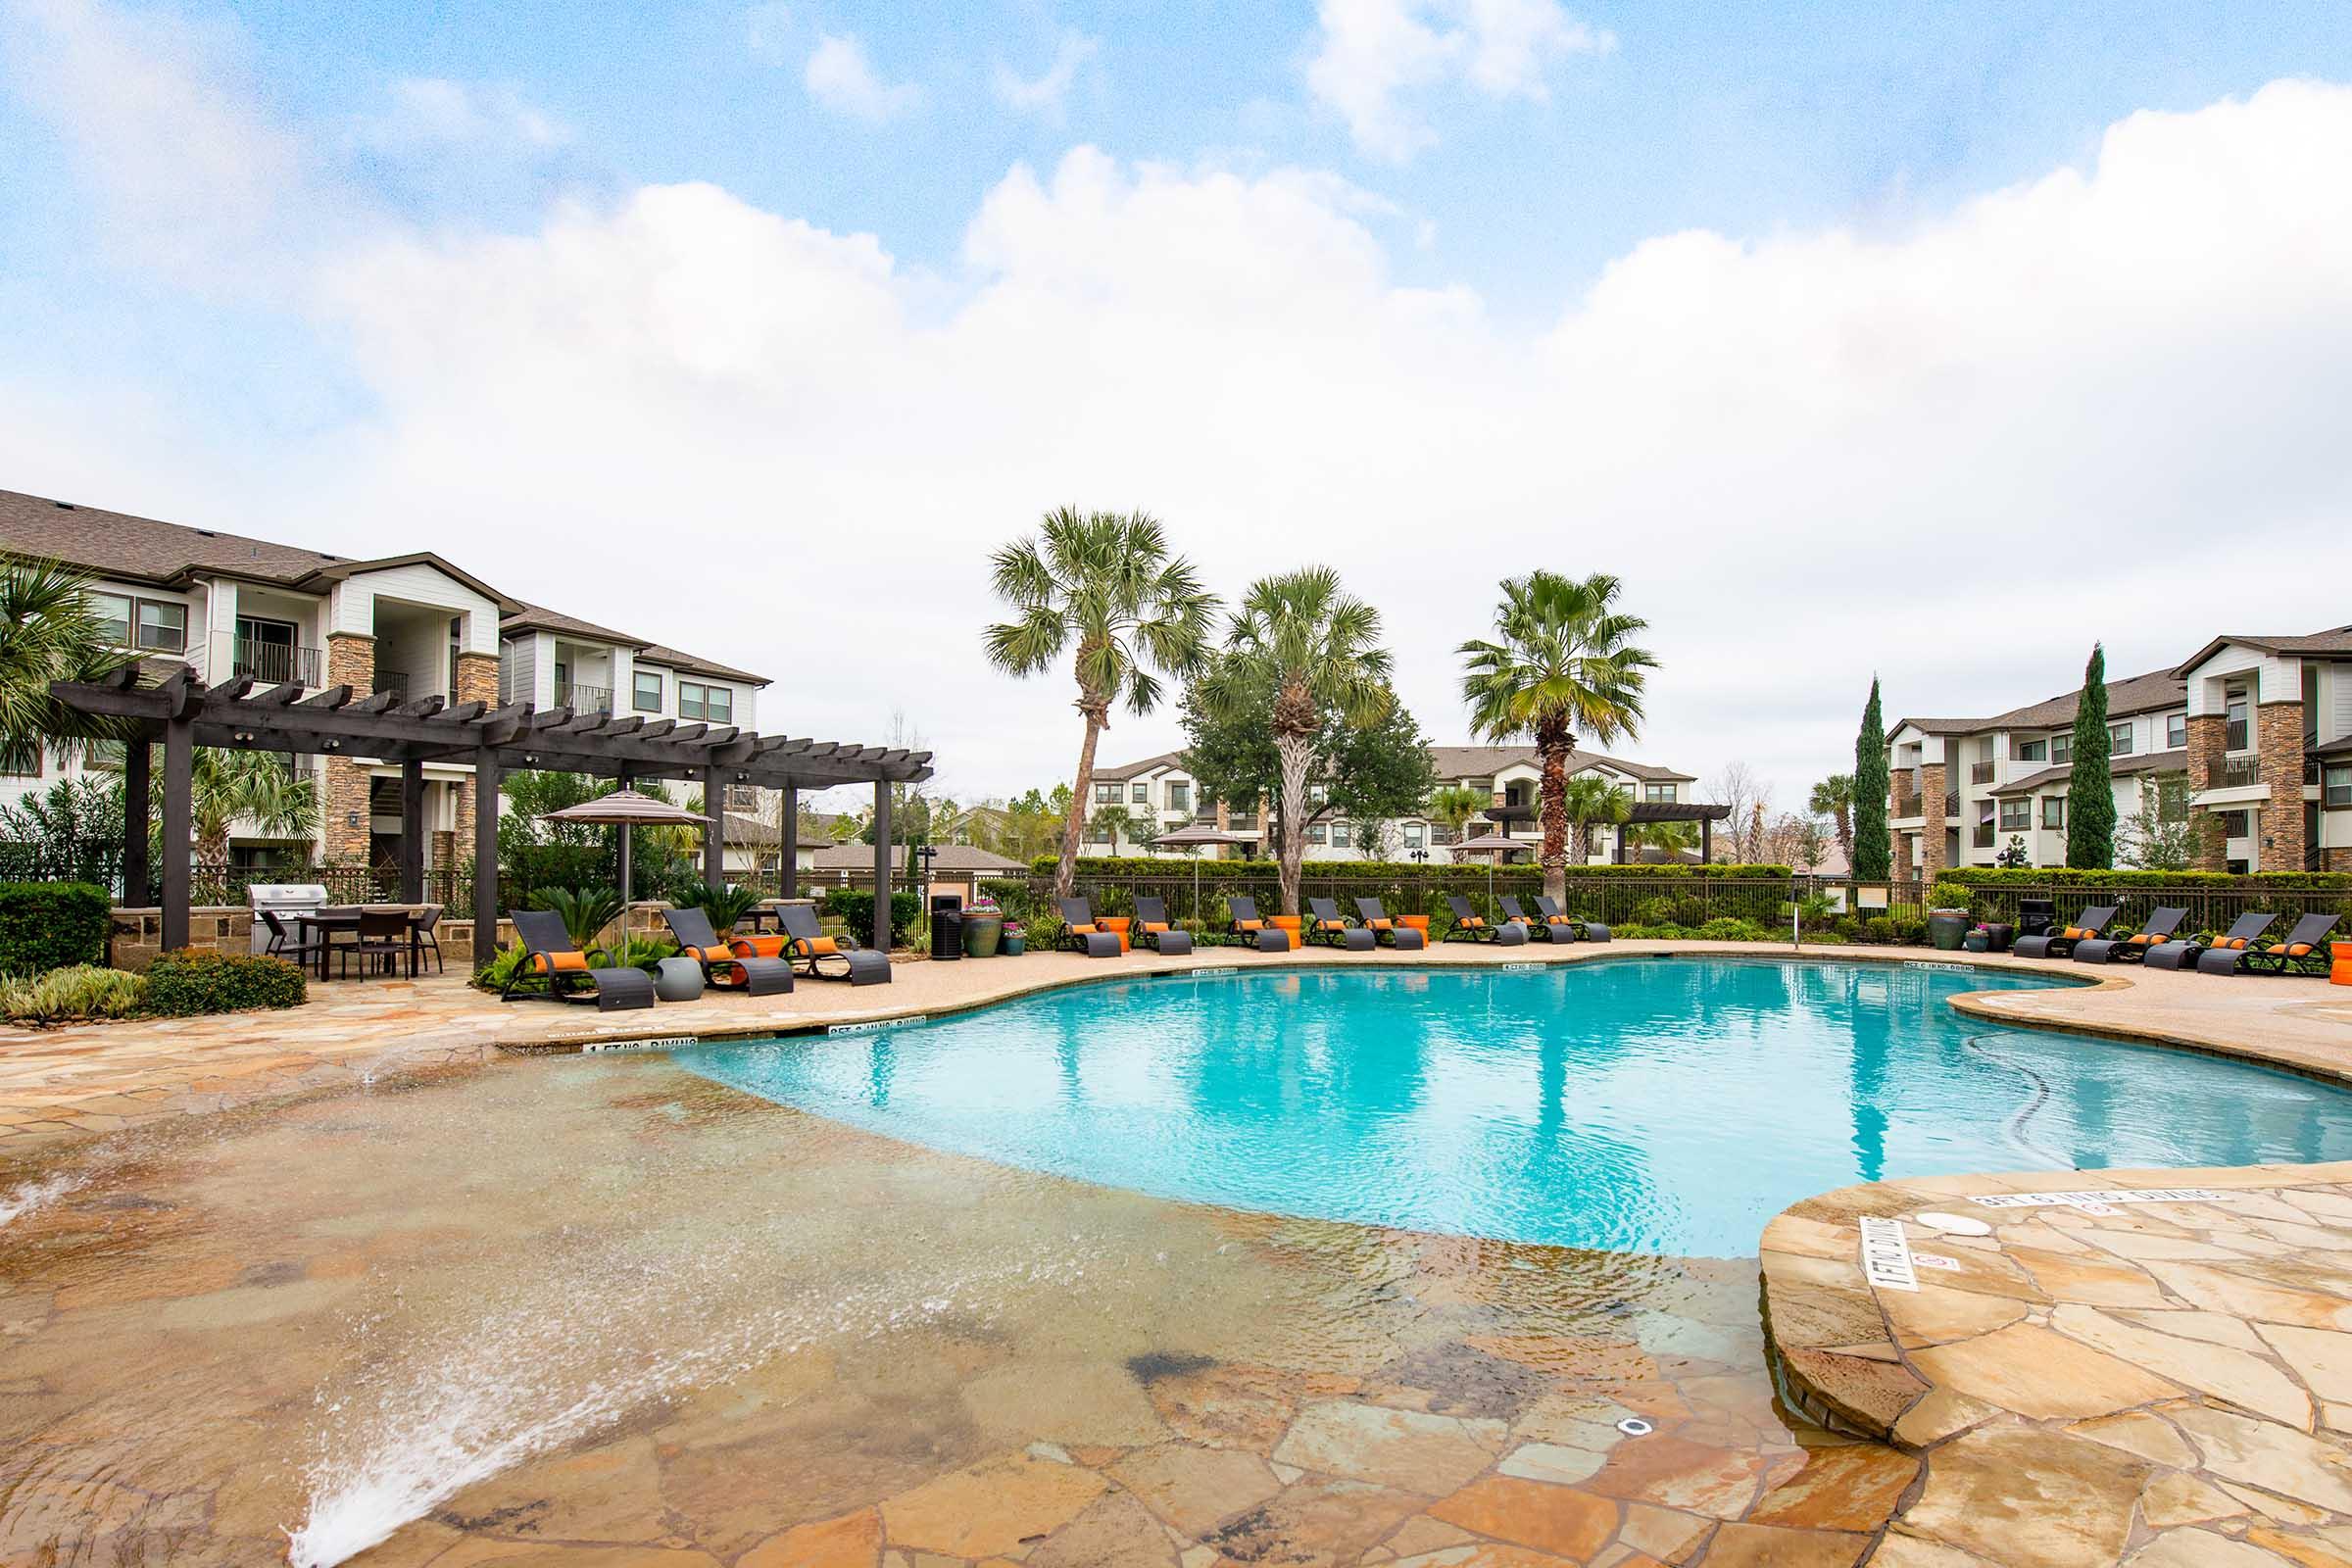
[1762,1163,2352,1568]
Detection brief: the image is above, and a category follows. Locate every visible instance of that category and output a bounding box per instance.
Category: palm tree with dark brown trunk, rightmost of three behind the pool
[1458,571,1658,898]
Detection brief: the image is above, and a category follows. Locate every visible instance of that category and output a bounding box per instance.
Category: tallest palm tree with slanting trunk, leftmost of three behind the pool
[986,508,1216,898]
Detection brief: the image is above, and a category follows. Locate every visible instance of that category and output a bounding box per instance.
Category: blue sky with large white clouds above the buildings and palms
[0,0,2352,822]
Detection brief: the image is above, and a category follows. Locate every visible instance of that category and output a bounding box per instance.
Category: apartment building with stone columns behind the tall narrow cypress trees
[1886,627,2352,879]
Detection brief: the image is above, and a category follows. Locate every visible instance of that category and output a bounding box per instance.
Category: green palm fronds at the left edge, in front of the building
[0,560,134,773]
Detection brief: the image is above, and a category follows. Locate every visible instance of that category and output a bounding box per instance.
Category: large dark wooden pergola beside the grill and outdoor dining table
[49,665,931,955]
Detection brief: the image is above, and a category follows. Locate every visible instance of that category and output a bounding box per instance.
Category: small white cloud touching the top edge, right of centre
[1307,0,1616,163]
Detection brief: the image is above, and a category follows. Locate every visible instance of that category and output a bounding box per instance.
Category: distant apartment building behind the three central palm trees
[1087,745,1719,862]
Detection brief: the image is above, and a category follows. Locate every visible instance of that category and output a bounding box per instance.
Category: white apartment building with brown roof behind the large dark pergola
[0,491,766,865]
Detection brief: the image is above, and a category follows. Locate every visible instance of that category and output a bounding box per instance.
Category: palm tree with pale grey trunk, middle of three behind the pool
[1200,566,1397,914]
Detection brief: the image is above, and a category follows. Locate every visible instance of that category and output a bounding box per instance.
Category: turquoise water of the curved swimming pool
[677,959,2352,1257]
